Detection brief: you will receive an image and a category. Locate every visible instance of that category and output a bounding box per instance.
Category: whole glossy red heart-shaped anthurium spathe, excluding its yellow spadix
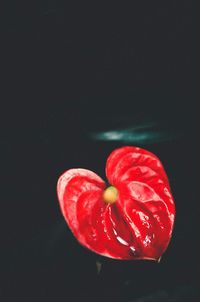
[57,146,175,260]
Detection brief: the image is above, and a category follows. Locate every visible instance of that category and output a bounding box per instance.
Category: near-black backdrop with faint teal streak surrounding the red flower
[0,0,200,302]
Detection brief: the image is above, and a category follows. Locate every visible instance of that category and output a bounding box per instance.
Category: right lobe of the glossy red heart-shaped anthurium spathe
[106,147,175,259]
